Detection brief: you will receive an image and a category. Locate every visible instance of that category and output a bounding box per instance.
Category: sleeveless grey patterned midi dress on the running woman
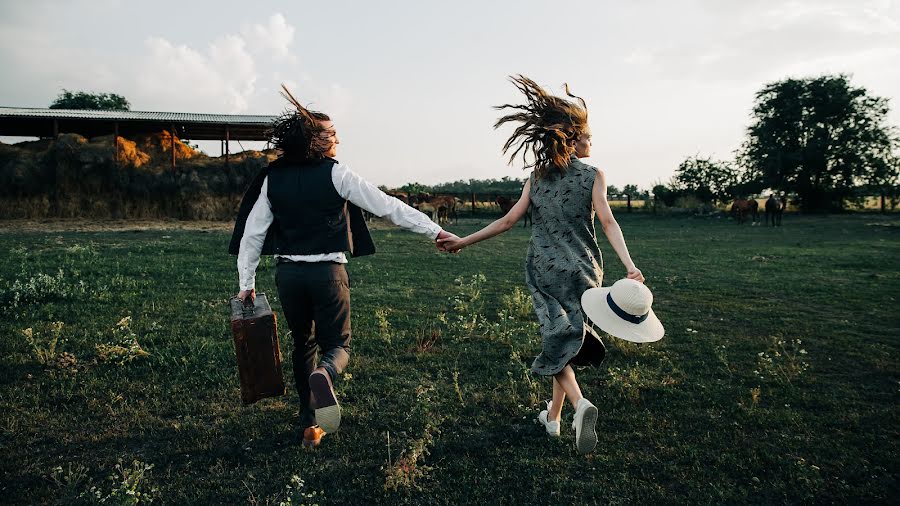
[525,157,606,376]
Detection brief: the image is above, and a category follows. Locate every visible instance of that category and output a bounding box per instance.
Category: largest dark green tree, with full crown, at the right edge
[740,75,898,211]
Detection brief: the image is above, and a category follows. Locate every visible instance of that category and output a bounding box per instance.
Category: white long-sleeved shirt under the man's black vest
[237,163,441,290]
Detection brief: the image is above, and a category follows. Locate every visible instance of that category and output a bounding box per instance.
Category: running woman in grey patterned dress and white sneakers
[438,75,644,454]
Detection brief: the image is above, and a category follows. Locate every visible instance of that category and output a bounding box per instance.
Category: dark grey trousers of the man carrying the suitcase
[275,261,350,428]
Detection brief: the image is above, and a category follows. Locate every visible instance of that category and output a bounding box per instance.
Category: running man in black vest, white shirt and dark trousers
[229,87,455,447]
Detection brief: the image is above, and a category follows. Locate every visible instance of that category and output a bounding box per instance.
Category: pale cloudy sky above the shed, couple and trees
[0,0,900,188]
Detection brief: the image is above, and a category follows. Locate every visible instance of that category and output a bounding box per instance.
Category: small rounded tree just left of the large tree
[672,156,738,203]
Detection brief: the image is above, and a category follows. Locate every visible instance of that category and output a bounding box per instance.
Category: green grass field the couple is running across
[0,213,900,504]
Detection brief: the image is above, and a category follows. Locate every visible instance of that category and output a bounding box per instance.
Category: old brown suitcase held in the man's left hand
[230,293,284,404]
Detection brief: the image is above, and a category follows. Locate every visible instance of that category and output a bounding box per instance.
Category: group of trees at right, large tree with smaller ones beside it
[653,74,900,211]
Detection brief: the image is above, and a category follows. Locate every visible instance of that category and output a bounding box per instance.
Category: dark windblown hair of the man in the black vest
[268,84,331,161]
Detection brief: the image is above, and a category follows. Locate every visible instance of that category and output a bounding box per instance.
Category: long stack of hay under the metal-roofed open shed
[0,132,276,220]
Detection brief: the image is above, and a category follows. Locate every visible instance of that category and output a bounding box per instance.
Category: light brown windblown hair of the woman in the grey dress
[494,74,587,178]
